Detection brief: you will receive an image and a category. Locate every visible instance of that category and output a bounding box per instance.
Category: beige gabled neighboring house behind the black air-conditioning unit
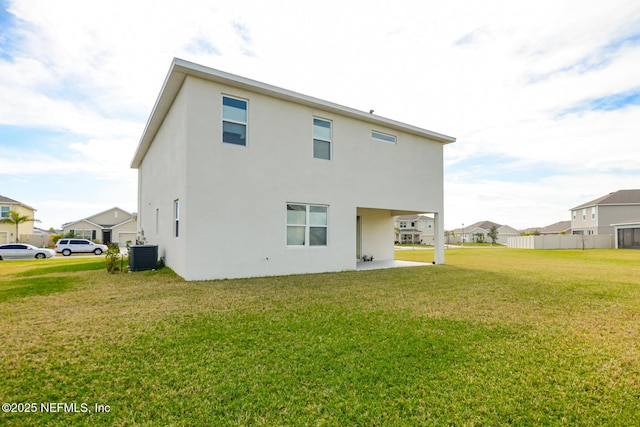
[62,207,137,247]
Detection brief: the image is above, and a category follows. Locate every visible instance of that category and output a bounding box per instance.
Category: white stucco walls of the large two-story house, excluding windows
[138,71,443,280]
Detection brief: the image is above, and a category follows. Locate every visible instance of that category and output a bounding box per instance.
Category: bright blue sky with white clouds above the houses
[0,0,640,229]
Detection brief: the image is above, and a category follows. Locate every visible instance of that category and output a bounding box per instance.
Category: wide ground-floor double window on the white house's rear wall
[287,203,328,246]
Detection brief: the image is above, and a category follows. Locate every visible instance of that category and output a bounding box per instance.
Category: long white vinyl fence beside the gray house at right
[507,234,615,249]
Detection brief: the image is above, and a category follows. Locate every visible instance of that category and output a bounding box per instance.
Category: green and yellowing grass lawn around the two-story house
[0,248,640,426]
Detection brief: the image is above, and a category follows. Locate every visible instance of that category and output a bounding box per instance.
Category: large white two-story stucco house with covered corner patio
[131,59,455,280]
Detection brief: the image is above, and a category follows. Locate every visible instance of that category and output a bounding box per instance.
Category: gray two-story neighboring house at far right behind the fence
[571,190,640,235]
